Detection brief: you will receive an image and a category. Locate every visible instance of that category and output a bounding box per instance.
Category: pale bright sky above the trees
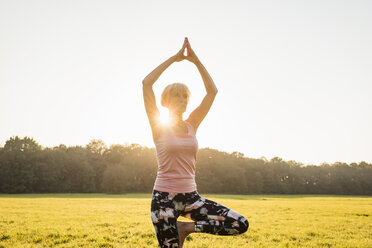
[0,0,372,164]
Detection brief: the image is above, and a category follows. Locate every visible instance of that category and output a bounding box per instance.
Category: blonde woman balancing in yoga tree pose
[143,38,249,247]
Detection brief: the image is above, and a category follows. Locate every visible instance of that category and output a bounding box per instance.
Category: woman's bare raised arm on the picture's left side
[142,39,186,138]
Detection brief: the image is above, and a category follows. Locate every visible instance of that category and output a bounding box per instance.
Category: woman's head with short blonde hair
[161,83,190,113]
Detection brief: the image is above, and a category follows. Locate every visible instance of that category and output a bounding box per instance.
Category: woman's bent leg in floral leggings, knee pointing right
[182,195,249,235]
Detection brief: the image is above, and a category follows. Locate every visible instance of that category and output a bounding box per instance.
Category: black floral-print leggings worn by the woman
[151,190,249,247]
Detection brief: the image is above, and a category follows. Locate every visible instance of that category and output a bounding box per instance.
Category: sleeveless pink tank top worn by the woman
[154,121,198,193]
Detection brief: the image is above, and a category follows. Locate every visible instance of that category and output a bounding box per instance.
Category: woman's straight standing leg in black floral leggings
[151,190,179,248]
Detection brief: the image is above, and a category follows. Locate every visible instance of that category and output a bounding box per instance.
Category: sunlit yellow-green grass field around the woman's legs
[0,194,372,248]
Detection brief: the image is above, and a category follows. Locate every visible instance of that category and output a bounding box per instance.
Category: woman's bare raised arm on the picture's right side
[186,39,218,132]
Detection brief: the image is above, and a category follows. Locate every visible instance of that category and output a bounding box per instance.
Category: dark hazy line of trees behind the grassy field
[0,136,372,195]
